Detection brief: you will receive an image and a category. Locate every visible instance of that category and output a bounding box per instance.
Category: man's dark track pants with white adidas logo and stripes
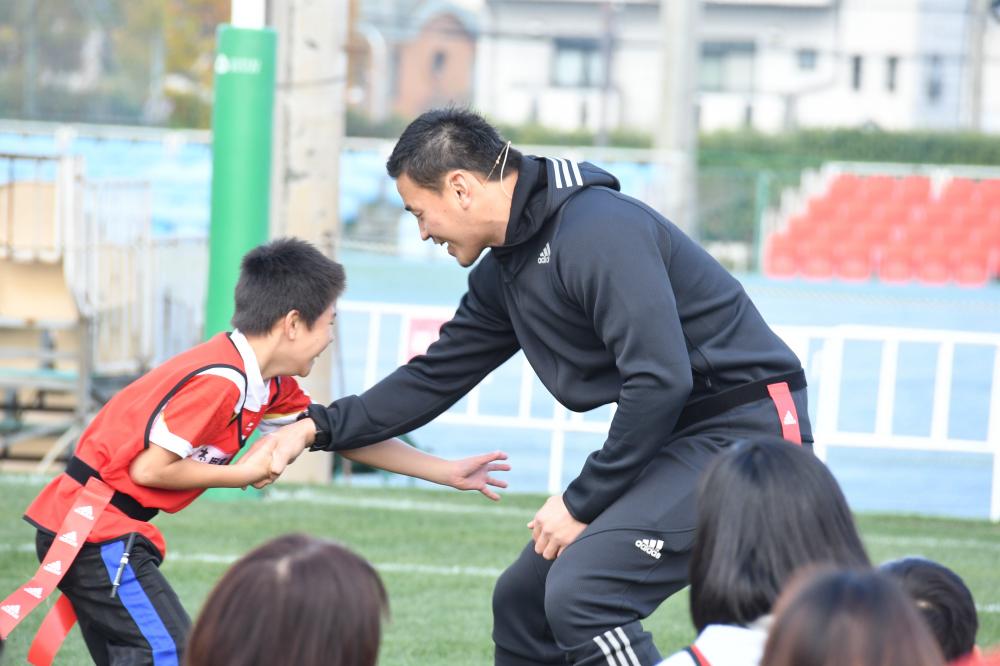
[493,390,812,666]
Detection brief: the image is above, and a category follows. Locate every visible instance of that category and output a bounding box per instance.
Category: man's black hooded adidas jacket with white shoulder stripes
[316,156,800,523]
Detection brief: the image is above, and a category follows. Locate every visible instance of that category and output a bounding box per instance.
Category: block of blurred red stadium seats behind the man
[780,173,1000,286]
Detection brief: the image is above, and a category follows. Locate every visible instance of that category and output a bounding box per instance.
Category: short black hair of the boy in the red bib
[232,238,346,335]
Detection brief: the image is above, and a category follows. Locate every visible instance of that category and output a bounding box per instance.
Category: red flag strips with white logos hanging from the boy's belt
[0,478,114,665]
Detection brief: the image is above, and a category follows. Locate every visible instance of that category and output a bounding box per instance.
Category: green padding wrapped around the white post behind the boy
[205,25,278,339]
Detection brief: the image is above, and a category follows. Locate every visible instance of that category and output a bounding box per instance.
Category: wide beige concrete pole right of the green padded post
[268,0,348,483]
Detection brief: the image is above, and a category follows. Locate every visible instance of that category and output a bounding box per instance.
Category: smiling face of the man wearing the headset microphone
[396,173,487,266]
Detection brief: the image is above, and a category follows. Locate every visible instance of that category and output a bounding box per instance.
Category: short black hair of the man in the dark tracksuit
[385,107,521,192]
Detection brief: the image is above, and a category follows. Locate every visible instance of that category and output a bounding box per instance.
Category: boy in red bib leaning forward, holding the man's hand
[0,239,509,666]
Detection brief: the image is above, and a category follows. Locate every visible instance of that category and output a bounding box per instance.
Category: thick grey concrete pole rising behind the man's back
[651,0,701,240]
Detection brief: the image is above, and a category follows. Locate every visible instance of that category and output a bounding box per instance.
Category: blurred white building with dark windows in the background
[475,0,1000,132]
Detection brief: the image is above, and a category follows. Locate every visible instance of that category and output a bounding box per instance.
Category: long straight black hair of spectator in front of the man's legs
[690,436,870,631]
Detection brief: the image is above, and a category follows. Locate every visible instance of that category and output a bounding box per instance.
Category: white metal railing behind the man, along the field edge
[338,301,1000,521]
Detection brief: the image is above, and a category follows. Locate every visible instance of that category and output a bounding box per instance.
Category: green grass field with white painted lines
[0,475,1000,666]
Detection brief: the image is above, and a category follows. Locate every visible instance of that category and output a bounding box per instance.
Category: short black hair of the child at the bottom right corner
[881,557,979,661]
